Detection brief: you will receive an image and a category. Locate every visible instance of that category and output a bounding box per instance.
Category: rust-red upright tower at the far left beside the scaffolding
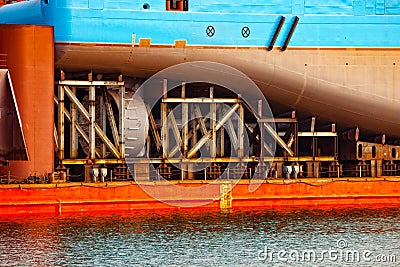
[0,25,54,178]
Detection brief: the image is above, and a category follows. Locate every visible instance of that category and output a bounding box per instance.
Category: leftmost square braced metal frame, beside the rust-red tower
[54,73,125,166]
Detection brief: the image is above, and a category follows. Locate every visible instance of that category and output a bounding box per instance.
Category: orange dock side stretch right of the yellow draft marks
[232,178,400,207]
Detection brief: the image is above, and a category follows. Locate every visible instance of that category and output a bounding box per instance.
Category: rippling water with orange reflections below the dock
[0,208,400,266]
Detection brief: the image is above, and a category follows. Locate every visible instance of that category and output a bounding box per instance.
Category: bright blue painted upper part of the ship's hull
[0,0,400,47]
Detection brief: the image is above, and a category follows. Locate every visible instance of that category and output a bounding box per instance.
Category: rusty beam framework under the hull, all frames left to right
[54,73,344,179]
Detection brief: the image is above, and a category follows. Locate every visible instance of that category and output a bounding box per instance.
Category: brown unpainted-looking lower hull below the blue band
[55,43,400,137]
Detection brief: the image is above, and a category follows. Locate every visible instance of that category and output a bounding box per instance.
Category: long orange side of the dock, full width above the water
[0,178,400,215]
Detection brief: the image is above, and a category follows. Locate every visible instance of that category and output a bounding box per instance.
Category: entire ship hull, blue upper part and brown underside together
[0,0,400,138]
